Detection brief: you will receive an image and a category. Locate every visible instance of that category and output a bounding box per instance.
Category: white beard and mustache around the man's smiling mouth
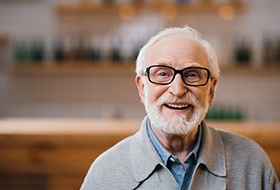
[144,89,209,135]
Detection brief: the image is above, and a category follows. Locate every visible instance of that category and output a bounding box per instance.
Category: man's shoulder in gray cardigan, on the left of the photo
[82,136,141,189]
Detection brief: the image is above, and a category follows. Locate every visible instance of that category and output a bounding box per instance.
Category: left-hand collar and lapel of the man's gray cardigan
[130,117,178,190]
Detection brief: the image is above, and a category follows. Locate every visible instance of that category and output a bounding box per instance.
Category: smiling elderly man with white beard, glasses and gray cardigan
[81,26,279,190]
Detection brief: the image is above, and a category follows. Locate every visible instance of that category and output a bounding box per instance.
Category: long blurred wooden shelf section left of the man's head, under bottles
[10,61,135,75]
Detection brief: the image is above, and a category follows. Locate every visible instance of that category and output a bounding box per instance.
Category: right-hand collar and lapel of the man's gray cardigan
[190,122,226,189]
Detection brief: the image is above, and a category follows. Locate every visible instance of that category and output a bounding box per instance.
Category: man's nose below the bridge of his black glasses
[169,74,188,97]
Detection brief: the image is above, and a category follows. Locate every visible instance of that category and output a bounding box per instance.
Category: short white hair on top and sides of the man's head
[136,26,220,78]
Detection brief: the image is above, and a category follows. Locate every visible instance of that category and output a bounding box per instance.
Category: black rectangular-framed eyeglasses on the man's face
[146,65,210,86]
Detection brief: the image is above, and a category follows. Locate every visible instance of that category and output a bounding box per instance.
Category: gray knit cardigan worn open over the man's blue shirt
[81,118,280,190]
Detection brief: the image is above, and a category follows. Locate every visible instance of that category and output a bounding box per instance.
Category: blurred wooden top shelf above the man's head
[56,1,246,14]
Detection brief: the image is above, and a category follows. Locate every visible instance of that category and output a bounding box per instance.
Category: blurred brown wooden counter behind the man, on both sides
[0,118,280,190]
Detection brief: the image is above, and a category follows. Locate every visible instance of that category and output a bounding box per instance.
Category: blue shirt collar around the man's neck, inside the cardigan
[146,119,202,166]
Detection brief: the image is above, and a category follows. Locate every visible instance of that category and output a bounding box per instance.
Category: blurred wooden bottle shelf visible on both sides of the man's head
[9,61,280,76]
